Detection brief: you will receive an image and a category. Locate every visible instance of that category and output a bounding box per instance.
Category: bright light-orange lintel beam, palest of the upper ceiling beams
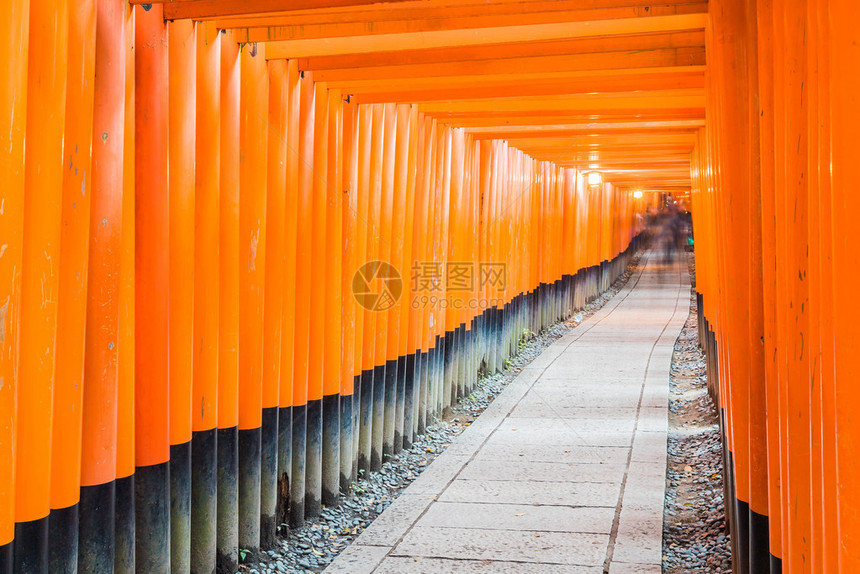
[266,14,707,59]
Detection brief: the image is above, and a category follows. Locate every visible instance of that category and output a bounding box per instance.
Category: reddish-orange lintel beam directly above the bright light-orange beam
[233,2,708,42]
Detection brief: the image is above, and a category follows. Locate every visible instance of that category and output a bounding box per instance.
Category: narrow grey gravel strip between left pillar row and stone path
[239,255,640,574]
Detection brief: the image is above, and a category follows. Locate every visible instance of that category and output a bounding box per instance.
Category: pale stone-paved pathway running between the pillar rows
[326,253,690,574]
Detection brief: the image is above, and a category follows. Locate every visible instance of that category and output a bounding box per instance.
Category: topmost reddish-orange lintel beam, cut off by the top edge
[161,0,416,20]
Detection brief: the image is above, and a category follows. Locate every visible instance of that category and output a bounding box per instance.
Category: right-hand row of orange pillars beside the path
[692,0,860,574]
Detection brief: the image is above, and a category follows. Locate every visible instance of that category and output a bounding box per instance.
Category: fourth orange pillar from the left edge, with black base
[77,1,125,572]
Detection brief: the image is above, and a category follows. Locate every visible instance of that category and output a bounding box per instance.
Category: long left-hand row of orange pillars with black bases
[0,0,654,572]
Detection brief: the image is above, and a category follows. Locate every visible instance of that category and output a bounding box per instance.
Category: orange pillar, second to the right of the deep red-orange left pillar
[190,21,221,572]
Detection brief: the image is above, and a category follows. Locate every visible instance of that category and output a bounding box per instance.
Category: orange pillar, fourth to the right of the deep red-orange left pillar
[238,39,269,556]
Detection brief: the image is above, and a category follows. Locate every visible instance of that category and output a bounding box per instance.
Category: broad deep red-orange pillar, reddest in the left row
[135,4,170,572]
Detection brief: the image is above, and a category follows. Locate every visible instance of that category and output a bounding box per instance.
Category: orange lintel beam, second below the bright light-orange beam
[310,47,705,82]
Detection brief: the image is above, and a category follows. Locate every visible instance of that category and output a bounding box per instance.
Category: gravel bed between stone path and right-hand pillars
[663,255,732,574]
